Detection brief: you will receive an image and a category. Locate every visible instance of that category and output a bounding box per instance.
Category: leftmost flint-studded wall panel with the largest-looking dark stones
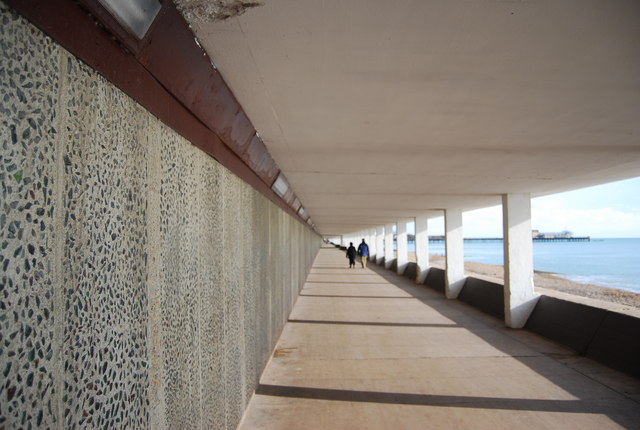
[0,2,59,428]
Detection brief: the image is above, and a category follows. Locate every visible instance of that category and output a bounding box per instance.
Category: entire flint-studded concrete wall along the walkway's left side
[0,2,320,429]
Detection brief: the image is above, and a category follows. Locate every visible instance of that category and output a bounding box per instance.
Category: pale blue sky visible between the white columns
[422,177,640,238]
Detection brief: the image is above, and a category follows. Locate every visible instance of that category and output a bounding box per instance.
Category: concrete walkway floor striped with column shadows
[239,248,640,430]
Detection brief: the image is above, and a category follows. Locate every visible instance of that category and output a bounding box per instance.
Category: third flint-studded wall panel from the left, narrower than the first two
[160,127,200,427]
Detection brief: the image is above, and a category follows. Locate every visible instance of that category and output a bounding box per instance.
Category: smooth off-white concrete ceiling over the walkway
[178,0,640,234]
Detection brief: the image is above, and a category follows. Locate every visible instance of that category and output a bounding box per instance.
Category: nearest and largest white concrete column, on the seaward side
[502,194,538,328]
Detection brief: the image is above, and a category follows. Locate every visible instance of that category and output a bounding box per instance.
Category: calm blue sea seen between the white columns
[409,238,640,293]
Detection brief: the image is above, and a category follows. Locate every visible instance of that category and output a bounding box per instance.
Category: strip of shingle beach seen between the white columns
[409,252,640,315]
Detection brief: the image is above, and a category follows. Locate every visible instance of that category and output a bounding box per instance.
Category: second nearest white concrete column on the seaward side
[444,209,465,299]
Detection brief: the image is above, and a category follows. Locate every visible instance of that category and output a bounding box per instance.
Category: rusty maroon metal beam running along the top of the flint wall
[6,0,306,224]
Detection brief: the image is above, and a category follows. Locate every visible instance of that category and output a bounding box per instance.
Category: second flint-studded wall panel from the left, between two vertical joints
[59,58,148,428]
